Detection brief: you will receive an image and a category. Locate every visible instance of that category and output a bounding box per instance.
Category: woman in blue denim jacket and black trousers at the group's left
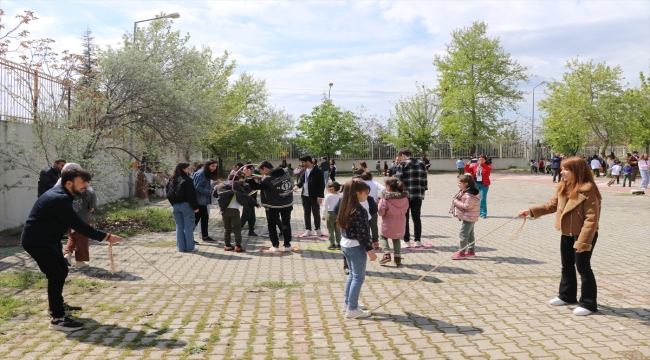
[192,159,219,241]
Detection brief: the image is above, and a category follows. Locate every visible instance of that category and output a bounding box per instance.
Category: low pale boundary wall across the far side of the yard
[224,158,528,172]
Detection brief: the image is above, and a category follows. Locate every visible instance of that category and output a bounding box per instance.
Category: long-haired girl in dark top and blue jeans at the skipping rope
[336,179,377,319]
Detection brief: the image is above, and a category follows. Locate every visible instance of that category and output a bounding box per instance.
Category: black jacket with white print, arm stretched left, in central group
[246,167,292,209]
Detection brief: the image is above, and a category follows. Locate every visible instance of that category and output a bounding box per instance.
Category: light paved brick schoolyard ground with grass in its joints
[0,173,650,359]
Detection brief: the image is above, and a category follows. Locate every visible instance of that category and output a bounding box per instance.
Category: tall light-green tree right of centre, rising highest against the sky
[433,22,529,152]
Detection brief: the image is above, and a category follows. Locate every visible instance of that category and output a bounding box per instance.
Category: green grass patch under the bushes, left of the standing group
[95,199,176,236]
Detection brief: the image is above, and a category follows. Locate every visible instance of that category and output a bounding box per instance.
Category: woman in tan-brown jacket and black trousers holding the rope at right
[519,157,602,316]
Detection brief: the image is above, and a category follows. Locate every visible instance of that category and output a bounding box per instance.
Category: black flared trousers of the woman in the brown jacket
[558,232,598,311]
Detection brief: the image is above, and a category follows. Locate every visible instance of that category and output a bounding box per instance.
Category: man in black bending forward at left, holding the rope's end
[20,168,122,331]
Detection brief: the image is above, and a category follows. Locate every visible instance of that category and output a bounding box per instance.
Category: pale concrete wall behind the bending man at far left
[0,121,128,230]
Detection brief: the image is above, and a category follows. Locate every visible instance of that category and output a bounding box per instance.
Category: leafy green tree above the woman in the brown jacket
[539,59,629,157]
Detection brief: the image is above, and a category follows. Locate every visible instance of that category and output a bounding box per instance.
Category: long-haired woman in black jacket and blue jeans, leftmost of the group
[167,162,199,252]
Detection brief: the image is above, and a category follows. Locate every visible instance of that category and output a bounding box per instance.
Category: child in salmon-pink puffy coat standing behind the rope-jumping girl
[377,177,409,266]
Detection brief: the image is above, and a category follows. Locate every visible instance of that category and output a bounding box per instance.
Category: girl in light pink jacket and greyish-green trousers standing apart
[451,175,481,260]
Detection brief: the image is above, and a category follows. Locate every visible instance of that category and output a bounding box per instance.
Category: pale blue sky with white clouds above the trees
[0,0,650,120]
